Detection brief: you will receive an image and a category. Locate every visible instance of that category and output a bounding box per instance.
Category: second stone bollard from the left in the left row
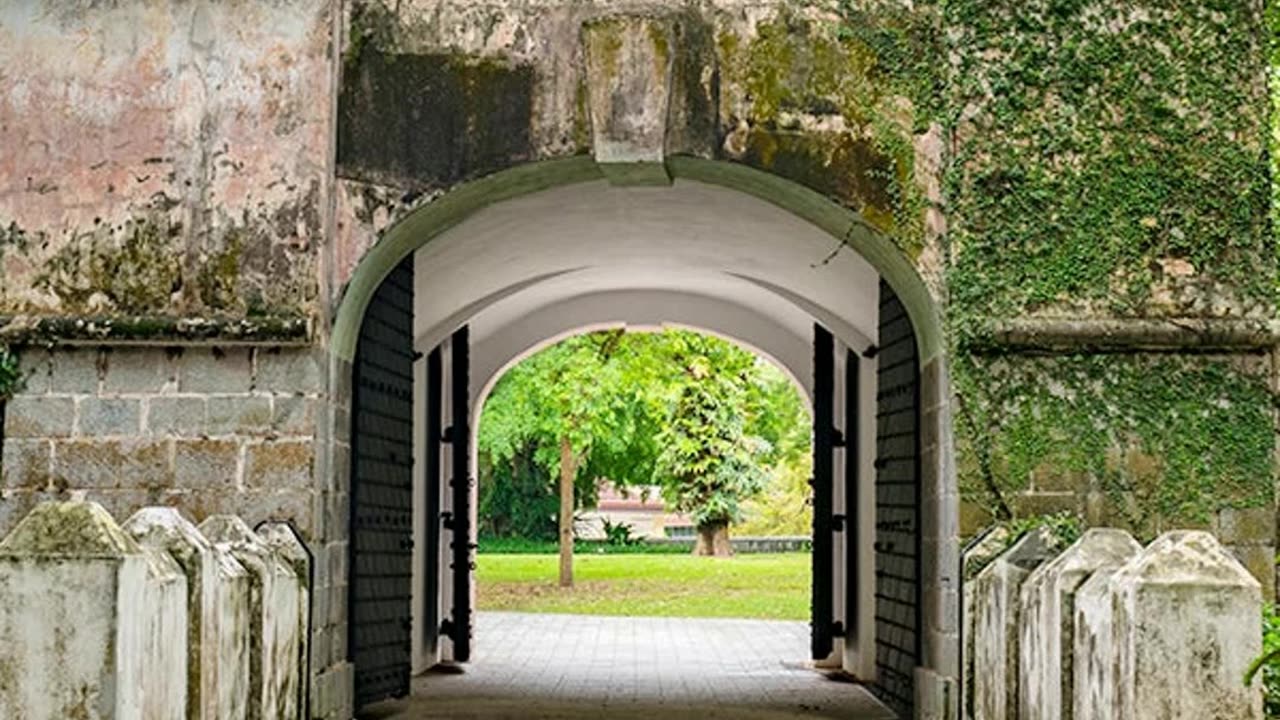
[124,507,250,720]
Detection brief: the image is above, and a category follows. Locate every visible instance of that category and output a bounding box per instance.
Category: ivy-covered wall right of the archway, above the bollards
[946,0,1276,589]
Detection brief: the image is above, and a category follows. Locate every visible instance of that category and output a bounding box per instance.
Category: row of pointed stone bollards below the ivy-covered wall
[965,528,1262,720]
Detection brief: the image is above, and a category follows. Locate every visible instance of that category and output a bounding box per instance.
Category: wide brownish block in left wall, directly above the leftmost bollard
[54,438,174,488]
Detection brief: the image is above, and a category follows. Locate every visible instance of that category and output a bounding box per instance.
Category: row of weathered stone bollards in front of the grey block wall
[0,501,311,720]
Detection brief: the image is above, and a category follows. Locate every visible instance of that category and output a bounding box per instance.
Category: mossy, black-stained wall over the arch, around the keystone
[335,0,945,292]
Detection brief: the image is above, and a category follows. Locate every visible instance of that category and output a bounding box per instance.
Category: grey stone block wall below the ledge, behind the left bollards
[0,347,325,537]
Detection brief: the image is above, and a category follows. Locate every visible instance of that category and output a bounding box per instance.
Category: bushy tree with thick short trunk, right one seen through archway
[657,333,769,556]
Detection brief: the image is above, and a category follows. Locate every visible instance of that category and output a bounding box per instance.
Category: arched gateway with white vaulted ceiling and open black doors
[332,158,957,714]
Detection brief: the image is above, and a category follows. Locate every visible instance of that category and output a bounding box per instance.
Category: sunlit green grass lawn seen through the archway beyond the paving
[476,552,812,620]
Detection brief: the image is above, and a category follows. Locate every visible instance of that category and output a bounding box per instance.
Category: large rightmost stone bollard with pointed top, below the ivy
[1076,530,1262,720]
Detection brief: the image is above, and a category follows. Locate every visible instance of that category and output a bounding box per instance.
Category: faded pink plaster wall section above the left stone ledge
[0,1,330,315]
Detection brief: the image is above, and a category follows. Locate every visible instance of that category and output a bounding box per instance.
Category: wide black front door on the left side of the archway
[348,259,413,707]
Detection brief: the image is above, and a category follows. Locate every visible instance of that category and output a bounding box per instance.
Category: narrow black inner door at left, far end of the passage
[442,327,476,662]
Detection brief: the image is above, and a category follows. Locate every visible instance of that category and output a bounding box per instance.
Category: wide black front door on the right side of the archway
[874,281,922,717]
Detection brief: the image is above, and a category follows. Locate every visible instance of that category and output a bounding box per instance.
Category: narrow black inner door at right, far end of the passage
[810,324,844,660]
